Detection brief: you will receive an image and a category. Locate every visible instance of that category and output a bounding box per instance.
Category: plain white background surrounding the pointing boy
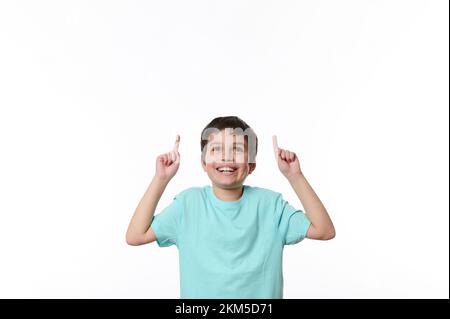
[0,0,449,298]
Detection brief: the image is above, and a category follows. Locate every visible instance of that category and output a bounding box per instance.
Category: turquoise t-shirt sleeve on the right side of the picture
[276,195,311,245]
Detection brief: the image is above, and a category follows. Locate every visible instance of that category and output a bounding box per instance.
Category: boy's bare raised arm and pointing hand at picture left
[126,135,180,246]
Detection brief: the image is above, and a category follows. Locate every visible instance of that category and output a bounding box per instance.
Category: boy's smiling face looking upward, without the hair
[202,130,256,189]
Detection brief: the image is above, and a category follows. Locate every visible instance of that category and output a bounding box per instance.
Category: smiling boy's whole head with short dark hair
[201,116,258,189]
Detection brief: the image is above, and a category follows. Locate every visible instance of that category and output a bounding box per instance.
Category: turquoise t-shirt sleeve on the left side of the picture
[150,196,183,247]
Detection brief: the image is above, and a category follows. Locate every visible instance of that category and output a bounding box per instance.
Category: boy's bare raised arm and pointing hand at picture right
[273,136,336,240]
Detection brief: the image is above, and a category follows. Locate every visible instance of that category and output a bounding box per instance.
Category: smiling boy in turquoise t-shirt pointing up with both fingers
[126,116,335,299]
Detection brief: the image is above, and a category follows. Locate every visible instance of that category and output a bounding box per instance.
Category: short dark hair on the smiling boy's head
[200,116,258,163]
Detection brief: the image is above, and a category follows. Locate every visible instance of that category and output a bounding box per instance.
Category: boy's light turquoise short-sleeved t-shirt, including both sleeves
[151,185,311,299]
